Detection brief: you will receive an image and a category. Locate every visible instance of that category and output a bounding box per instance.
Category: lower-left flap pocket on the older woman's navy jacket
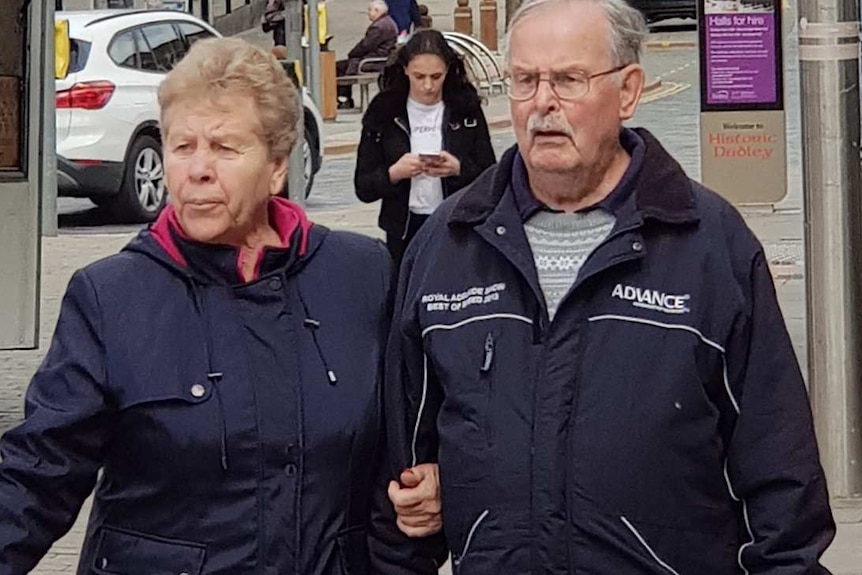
[93,527,206,575]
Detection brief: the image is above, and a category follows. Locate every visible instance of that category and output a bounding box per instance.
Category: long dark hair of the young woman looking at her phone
[379,30,480,107]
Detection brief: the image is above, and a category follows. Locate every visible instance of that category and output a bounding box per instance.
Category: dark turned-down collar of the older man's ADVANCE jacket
[449,128,699,230]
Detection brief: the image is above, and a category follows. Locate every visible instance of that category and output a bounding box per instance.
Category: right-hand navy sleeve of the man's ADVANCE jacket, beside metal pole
[726,250,835,575]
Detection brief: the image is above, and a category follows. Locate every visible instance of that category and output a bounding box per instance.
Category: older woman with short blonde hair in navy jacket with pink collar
[0,39,436,575]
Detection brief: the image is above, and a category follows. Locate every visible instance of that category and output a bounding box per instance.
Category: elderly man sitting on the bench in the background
[335,0,398,109]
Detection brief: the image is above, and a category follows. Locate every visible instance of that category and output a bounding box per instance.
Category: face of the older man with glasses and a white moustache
[509,2,643,173]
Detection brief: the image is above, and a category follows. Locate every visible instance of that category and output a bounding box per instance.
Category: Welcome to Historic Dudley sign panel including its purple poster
[699,0,787,204]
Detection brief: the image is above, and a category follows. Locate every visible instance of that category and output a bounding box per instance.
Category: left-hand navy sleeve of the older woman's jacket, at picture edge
[0,271,111,575]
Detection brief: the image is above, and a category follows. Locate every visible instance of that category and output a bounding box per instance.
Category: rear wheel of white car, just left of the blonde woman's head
[113,134,167,222]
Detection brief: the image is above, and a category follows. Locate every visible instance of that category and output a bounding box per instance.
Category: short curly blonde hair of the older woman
[159,38,300,159]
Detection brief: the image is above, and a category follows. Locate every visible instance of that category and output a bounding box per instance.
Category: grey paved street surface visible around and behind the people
[6,0,862,575]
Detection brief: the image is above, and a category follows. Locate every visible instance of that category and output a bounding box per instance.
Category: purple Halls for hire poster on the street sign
[704,0,778,105]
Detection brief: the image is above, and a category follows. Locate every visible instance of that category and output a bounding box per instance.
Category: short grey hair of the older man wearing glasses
[504,0,649,66]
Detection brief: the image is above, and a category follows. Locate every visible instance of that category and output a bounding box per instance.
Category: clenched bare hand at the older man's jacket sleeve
[389,463,443,537]
